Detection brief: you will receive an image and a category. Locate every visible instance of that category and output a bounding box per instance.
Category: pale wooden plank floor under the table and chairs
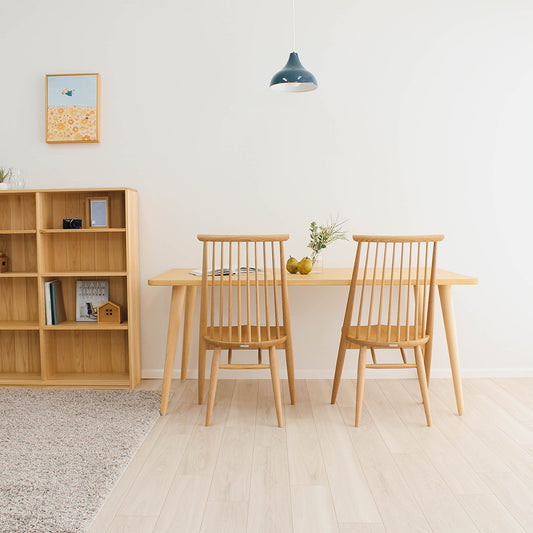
[91,378,533,533]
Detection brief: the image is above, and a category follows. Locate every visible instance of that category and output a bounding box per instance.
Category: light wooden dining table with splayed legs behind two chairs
[148,268,478,415]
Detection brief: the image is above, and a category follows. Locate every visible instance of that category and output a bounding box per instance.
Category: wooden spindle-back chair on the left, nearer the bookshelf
[198,235,292,427]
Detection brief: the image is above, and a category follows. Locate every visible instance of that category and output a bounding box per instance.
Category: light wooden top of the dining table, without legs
[148,268,478,287]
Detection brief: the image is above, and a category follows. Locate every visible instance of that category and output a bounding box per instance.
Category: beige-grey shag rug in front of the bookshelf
[0,389,161,533]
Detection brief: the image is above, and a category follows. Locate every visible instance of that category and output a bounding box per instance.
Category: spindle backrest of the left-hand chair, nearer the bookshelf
[198,235,289,342]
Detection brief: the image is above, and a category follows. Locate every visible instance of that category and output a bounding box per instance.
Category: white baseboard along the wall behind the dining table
[142,368,533,379]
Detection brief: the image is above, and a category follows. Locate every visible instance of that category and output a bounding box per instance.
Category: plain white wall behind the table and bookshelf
[0,0,533,377]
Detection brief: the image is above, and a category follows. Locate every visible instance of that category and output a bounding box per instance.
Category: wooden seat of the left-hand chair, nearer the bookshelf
[204,325,287,350]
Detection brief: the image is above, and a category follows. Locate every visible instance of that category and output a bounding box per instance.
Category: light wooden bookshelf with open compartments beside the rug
[0,188,141,389]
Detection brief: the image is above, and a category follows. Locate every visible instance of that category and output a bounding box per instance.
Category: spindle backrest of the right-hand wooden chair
[344,235,444,343]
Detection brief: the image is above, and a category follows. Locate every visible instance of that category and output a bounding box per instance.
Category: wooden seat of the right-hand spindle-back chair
[345,324,429,348]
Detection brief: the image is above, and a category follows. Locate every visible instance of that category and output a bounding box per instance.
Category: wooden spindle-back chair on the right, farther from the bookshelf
[331,235,444,426]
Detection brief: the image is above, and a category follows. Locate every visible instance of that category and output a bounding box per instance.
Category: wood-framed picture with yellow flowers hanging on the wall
[46,74,100,143]
